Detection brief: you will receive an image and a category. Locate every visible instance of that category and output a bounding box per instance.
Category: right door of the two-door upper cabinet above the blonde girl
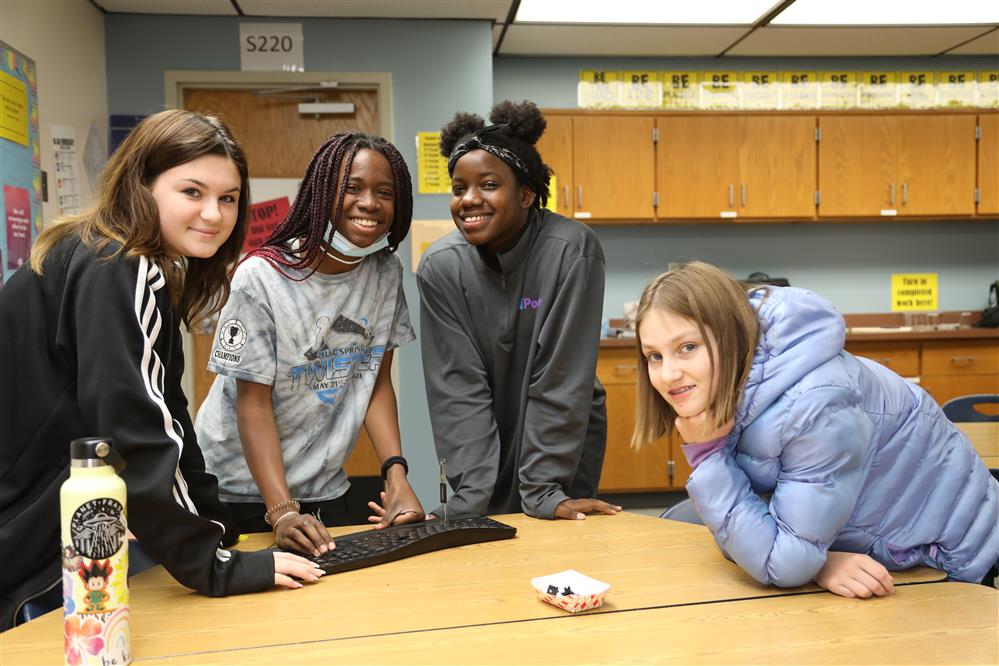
[736,115,817,218]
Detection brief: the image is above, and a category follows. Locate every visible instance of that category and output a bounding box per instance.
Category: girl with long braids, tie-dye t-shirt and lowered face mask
[196,132,424,556]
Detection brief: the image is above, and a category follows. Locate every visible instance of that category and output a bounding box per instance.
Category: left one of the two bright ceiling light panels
[515,0,777,25]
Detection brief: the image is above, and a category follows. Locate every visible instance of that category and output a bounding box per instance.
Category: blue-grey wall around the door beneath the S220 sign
[105,14,493,509]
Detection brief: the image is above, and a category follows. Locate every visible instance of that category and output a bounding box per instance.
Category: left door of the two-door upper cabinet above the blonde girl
[656,116,739,219]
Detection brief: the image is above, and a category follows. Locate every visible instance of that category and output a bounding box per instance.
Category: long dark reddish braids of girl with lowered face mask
[247,131,413,280]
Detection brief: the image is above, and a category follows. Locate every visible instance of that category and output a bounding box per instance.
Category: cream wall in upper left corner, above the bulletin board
[0,0,108,223]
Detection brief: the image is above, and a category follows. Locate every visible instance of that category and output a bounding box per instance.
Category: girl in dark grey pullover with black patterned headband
[406,101,620,520]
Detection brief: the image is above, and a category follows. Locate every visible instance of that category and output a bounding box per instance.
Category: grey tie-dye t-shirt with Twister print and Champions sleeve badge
[195,252,416,502]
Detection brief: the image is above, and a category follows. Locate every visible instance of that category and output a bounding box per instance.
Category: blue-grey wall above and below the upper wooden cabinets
[493,57,999,317]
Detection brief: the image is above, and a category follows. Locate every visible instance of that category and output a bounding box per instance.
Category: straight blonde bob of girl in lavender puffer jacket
[631,261,760,448]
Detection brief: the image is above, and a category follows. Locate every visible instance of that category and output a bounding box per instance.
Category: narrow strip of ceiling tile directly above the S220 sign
[236,0,512,22]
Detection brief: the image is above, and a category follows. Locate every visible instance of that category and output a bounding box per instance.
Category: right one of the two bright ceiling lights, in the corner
[770,0,999,25]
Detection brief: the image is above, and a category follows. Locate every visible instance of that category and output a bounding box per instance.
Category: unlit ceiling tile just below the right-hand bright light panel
[726,26,982,56]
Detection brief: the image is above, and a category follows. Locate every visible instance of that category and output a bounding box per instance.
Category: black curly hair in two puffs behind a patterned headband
[441,100,552,208]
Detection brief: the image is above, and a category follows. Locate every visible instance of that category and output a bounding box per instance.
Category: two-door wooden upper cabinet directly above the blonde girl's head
[656,115,815,219]
